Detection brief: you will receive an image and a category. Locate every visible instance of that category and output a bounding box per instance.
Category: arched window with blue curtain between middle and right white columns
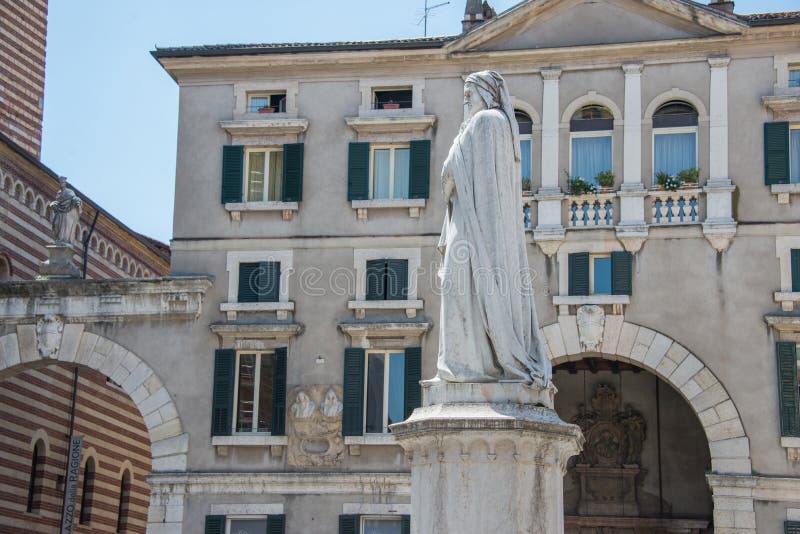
[653,100,697,181]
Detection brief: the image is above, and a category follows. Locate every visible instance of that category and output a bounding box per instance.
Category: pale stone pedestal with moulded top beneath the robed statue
[391,380,583,534]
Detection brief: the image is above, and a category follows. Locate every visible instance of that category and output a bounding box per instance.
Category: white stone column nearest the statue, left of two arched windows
[533,69,566,256]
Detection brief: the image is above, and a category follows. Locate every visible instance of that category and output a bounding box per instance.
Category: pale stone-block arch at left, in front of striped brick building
[0,330,189,472]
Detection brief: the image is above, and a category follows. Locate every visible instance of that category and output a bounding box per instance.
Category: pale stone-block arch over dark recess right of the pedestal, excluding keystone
[543,315,752,475]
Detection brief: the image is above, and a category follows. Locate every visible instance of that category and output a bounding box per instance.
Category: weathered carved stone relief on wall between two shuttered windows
[287,385,344,467]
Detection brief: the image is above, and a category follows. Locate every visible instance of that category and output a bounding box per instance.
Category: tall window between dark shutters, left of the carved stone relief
[233,352,275,433]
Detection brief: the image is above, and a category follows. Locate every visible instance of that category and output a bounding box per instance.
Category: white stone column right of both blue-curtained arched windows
[703,57,736,252]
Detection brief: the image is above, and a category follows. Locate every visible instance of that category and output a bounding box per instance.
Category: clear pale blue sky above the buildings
[42,0,800,241]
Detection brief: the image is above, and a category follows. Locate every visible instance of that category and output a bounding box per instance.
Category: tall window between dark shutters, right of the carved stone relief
[364,351,406,434]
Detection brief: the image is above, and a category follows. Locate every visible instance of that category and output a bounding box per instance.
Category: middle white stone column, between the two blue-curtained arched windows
[617,63,647,252]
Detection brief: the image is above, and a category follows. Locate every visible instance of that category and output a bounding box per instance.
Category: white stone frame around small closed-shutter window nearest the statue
[350,247,424,319]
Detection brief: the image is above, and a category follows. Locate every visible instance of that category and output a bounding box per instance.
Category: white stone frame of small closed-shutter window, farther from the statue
[220,250,294,321]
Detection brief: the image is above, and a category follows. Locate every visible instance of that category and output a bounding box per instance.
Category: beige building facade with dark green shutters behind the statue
[0,0,800,534]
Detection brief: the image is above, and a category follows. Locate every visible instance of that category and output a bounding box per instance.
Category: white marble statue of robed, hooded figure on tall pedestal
[437,71,552,387]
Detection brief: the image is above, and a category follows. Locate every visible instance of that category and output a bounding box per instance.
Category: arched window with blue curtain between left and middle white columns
[569,105,614,185]
